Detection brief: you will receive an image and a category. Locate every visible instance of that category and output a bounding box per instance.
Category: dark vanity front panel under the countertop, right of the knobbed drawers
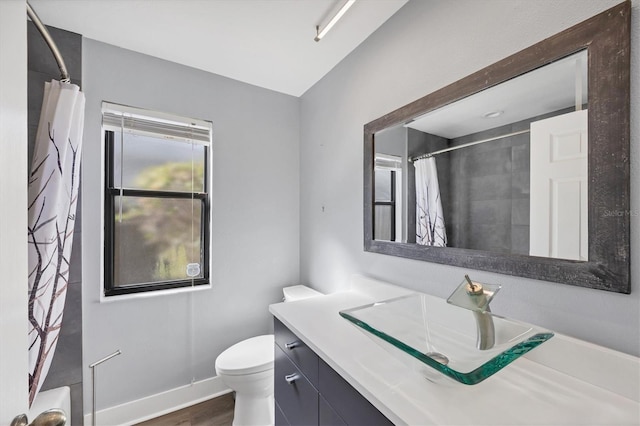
[318,360,393,426]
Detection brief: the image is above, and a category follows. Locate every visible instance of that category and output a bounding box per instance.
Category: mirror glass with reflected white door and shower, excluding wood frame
[373,50,588,261]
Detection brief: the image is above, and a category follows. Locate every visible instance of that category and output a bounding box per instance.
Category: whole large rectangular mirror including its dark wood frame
[364,1,630,293]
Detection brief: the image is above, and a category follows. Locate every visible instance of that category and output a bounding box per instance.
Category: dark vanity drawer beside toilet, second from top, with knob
[274,346,318,426]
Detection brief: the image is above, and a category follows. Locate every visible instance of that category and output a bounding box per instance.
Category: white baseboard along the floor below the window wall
[84,377,231,426]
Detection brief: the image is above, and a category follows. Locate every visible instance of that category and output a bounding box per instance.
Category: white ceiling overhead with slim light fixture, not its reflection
[30,0,408,96]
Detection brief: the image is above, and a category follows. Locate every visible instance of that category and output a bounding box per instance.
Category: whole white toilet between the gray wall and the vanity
[216,285,321,426]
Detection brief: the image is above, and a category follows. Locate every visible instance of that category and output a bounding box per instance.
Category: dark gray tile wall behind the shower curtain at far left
[27,22,83,425]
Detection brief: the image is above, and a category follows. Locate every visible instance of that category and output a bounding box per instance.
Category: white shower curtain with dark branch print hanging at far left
[28,80,85,405]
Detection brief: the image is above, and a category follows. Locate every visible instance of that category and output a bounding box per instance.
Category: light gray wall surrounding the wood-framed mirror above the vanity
[300,0,640,355]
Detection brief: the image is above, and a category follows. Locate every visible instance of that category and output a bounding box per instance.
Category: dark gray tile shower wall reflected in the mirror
[437,105,586,255]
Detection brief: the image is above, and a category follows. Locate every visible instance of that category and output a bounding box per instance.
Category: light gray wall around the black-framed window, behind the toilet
[82,39,300,412]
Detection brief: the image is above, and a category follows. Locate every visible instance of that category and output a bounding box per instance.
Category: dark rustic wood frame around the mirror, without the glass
[364,0,631,294]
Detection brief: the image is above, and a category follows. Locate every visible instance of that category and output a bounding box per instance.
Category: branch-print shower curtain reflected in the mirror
[413,157,447,247]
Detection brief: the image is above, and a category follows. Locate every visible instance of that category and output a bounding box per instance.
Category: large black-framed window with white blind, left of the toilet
[102,102,211,296]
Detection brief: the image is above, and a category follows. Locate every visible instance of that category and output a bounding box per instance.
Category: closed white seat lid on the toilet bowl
[216,334,274,376]
